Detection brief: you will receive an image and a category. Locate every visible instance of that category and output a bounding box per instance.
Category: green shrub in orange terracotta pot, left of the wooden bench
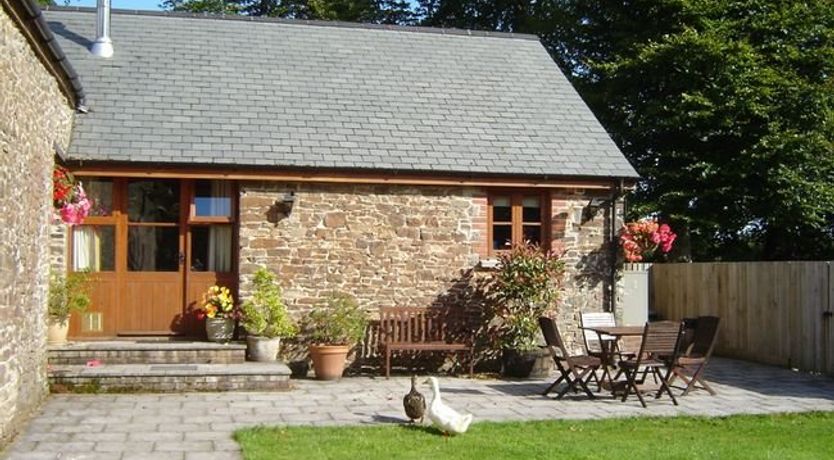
[304,292,368,380]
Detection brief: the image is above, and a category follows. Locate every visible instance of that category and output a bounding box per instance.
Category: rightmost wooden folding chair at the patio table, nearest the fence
[669,316,721,396]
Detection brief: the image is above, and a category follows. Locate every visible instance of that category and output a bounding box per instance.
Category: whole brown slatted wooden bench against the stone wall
[379,307,475,378]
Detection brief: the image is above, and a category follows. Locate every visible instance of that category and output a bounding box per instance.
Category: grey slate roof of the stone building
[45,8,636,178]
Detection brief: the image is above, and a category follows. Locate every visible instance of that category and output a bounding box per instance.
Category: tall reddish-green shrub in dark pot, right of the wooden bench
[490,244,565,377]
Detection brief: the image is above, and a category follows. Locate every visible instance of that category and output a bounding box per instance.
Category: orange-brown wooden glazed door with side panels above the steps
[69,177,237,337]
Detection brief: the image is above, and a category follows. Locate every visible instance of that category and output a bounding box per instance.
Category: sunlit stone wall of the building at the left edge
[0,9,73,448]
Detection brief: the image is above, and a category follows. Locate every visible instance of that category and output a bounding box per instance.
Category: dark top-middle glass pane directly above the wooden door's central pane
[127,180,180,222]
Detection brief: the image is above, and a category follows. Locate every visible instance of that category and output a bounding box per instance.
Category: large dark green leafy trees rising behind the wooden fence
[420,0,834,260]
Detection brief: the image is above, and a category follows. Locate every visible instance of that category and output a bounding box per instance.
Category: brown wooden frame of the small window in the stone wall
[487,189,551,257]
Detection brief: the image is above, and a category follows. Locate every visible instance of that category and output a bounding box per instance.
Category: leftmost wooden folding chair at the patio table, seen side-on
[539,316,602,399]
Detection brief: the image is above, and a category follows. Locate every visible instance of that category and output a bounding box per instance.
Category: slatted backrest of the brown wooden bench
[379,307,471,343]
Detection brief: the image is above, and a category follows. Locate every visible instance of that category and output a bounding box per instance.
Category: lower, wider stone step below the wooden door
[48,363,290,393]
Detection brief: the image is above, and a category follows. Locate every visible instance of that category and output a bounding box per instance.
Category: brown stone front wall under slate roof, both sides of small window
[240,182,610,354]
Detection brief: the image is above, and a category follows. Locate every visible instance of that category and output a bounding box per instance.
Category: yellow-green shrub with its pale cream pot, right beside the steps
[241,268,297,362]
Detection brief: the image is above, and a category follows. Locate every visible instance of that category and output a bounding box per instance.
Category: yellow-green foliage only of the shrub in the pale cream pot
[241,267,298,338]
